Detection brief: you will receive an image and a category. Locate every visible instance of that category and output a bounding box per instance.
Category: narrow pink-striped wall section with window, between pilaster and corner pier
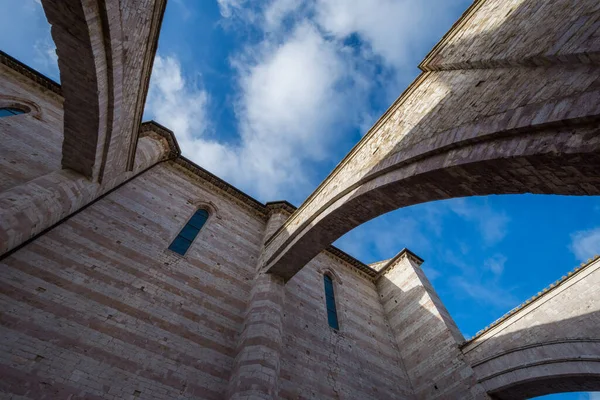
[279,253,412,400]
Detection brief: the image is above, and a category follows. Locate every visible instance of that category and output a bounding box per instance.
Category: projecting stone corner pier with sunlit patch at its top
[375,249,488,399]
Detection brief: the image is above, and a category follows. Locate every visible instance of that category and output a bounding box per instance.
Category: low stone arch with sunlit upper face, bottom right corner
[462,259,600,400]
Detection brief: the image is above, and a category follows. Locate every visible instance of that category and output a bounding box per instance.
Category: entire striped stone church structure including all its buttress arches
[0,0,600,400]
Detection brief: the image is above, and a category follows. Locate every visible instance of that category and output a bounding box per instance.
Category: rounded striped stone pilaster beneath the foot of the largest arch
[227,210,287,400]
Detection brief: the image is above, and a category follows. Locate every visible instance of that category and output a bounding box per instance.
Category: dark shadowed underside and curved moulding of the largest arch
[269,120,600,280]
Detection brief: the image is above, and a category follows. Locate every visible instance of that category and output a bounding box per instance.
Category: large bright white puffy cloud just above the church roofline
[146,23,366,200]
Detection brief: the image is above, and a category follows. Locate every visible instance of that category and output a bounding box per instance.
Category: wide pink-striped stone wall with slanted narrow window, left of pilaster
[0,163,264,399]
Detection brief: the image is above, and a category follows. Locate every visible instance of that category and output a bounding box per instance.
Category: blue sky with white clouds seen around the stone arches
[0,0,600,399]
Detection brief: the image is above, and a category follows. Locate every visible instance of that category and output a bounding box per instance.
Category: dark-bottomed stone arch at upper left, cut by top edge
[42,0,166,181]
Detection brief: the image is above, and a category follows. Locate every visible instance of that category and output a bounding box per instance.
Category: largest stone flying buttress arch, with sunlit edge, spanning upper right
[264,0,600,280]
